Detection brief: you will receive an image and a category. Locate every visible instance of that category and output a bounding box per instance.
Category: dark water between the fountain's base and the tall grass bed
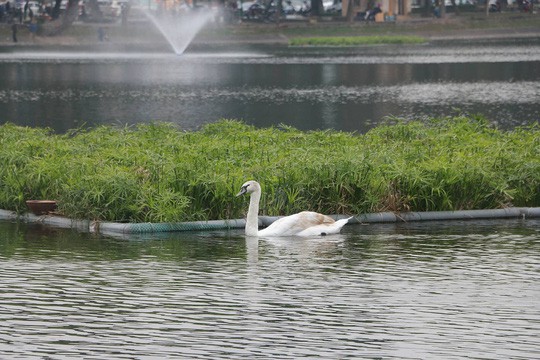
[0,40,540,132]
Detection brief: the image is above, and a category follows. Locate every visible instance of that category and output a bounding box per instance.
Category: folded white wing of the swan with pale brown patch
[259,211,343,236]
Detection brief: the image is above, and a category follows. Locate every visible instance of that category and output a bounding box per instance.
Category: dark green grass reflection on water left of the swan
[0,221,246,261]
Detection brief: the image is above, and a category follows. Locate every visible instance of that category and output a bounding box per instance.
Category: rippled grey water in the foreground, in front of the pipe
[0,220,540,360]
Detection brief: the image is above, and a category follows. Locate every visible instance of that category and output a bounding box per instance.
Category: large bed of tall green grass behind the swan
[0,117,540,222]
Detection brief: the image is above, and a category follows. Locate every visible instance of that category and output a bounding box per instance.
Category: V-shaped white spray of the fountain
[144,10,213,55]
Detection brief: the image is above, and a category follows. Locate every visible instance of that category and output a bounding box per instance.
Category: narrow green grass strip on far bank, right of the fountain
[289,35,426,46]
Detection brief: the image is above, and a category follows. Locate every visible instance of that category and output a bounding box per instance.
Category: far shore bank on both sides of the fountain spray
[0,12,540,50]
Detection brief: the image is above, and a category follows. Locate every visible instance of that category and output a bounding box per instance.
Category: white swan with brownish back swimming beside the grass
[236,180,352,237]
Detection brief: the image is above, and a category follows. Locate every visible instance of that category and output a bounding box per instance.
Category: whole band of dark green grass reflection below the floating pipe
[0,220,539,262]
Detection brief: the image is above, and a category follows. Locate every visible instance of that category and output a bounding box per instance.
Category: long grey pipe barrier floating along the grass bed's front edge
[0,207,540,235]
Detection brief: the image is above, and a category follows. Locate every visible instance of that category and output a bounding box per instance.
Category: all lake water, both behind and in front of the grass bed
[0,40,540,360]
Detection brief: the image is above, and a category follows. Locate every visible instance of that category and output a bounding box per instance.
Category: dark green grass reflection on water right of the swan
[343,219,540,266]
